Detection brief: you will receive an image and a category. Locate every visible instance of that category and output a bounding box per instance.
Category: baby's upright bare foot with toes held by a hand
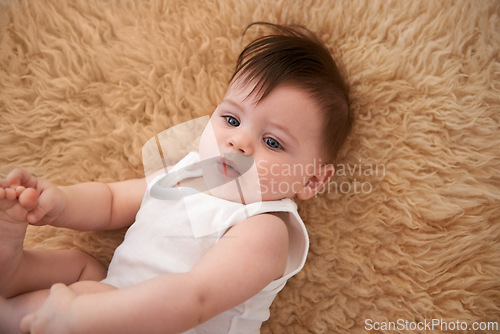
[0,186,38,292]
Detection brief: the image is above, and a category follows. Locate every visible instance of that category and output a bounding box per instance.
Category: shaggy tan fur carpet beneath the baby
[0,0,500,333]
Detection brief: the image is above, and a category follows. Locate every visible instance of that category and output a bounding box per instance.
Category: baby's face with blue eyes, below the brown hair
[200,82,323,203]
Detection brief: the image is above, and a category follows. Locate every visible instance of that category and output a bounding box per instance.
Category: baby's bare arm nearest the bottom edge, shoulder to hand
[23,214,288,334]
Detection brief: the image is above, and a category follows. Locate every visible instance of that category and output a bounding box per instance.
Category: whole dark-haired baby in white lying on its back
[0,24,352,334]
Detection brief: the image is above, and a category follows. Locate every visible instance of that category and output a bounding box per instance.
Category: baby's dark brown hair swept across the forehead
[230,22,353,163]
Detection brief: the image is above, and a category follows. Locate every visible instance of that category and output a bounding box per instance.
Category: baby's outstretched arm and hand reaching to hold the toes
[3,169,147,231]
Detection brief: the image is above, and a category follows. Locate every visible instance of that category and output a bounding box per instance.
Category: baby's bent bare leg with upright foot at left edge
[0,188,106,298]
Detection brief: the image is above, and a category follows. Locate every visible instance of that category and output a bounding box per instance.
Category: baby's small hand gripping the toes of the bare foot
[0,168,65,225]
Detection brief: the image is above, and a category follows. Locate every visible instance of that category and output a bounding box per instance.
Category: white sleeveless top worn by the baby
[103,152,309,334]
